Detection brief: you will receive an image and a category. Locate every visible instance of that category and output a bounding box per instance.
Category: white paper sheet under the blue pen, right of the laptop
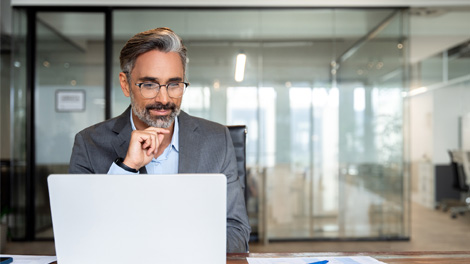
[247,256,385,264]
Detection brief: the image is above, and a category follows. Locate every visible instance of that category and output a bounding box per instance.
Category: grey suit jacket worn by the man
[69,107,251,252]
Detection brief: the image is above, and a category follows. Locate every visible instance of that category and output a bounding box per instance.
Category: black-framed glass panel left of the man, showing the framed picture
[10,10,105,240]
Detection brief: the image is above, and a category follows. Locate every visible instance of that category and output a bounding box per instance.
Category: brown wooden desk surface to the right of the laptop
[227,251,470,264]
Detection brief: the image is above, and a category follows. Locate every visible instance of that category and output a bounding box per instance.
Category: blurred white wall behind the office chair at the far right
[409,82,470,165]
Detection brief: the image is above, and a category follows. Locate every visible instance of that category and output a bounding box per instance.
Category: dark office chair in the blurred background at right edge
[449,150,470,218]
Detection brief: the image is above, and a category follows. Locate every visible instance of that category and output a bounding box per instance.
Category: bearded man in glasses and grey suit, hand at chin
[69,28,250,252]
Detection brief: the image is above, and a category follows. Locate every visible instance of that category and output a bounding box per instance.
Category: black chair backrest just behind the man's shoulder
[227,125,248,203]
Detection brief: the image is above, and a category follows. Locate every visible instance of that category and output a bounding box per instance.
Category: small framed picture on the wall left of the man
[55,90,85,112]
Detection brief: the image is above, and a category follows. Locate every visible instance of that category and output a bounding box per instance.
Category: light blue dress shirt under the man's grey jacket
[108,111,179,174]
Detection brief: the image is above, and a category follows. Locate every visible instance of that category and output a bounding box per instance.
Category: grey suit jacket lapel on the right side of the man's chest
[178,111,201,173]
